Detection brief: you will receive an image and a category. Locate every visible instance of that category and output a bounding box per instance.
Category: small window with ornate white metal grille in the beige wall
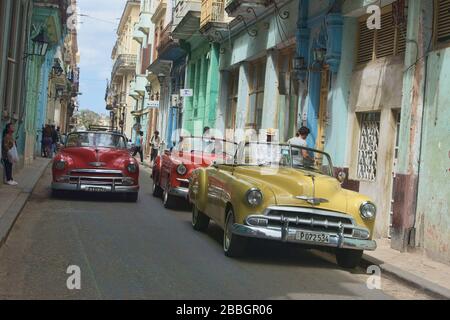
[357,112,380,181]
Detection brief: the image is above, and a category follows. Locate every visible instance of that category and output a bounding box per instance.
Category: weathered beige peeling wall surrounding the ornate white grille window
[348,57,404,237]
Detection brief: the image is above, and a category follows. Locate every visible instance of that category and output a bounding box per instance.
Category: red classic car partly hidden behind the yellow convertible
[152,137,235,208]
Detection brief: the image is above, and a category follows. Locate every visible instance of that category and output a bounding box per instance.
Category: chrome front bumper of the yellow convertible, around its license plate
[232,224,377,251]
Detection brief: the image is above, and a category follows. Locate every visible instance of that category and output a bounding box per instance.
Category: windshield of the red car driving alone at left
[66,132,126,149]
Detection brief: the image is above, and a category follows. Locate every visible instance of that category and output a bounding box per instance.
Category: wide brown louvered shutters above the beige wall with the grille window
[357,0,408,64]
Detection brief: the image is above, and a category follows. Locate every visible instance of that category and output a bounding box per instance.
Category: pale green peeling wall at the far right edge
[416,48,450,263]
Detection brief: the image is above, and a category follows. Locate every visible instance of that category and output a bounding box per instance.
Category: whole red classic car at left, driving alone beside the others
[52,131,139,202]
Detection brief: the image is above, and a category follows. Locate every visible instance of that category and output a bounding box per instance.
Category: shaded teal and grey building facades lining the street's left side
[0,0,79,170]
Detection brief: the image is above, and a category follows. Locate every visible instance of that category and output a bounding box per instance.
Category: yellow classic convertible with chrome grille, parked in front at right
[189,142,376,268]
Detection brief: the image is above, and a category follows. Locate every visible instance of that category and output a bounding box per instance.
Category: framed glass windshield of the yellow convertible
[236,142,333,176]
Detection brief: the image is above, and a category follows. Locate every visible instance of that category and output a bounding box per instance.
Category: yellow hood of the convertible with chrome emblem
[235,167,348,212]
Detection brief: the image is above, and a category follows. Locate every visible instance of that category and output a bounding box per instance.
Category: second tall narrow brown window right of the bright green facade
[246,58,266,130]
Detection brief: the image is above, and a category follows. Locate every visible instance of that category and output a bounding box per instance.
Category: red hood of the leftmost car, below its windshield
[61,148,131,169]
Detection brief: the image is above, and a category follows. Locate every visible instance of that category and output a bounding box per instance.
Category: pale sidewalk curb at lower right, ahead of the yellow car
[362,254,450,300]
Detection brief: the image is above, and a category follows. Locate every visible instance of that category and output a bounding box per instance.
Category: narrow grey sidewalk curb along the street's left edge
[0,161,50,248]
